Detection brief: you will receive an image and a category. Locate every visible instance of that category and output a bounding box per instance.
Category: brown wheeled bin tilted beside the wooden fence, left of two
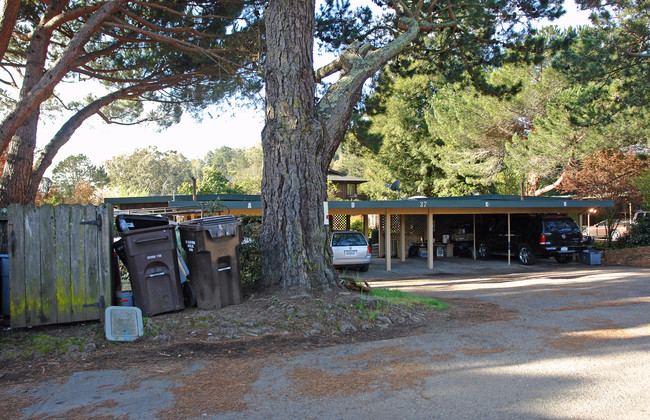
[122,225,185,315]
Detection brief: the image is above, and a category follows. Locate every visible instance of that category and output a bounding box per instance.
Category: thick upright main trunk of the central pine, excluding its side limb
[260,0,336,291]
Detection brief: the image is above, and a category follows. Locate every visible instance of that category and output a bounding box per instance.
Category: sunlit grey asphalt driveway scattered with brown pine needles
[6,262,650,419]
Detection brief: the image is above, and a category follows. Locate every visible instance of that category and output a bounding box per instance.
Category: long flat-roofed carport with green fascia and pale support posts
[105,195,614,271]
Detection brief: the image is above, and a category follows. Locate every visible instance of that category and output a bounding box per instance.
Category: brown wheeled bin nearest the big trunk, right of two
[178,215,242,309]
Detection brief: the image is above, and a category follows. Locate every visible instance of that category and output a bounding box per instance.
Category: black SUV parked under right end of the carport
[476,214,584,265]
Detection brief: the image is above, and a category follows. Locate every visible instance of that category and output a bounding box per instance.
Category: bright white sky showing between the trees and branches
[37,0,588,176]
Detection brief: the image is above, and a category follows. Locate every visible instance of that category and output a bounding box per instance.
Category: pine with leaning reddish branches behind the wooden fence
[0,0,263,205]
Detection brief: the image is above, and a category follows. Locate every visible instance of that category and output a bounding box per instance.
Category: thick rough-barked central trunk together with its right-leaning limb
[260,0,420,291]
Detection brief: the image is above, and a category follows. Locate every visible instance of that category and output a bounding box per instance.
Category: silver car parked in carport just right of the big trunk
[330,230,372,271]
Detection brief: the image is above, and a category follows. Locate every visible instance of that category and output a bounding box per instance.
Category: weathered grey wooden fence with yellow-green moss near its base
[7,204,113,327]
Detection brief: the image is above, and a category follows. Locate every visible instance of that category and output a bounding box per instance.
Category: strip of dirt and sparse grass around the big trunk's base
[0,291,512,386]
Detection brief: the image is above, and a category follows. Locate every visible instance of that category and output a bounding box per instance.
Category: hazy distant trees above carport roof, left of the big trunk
[38,145,262,204]
